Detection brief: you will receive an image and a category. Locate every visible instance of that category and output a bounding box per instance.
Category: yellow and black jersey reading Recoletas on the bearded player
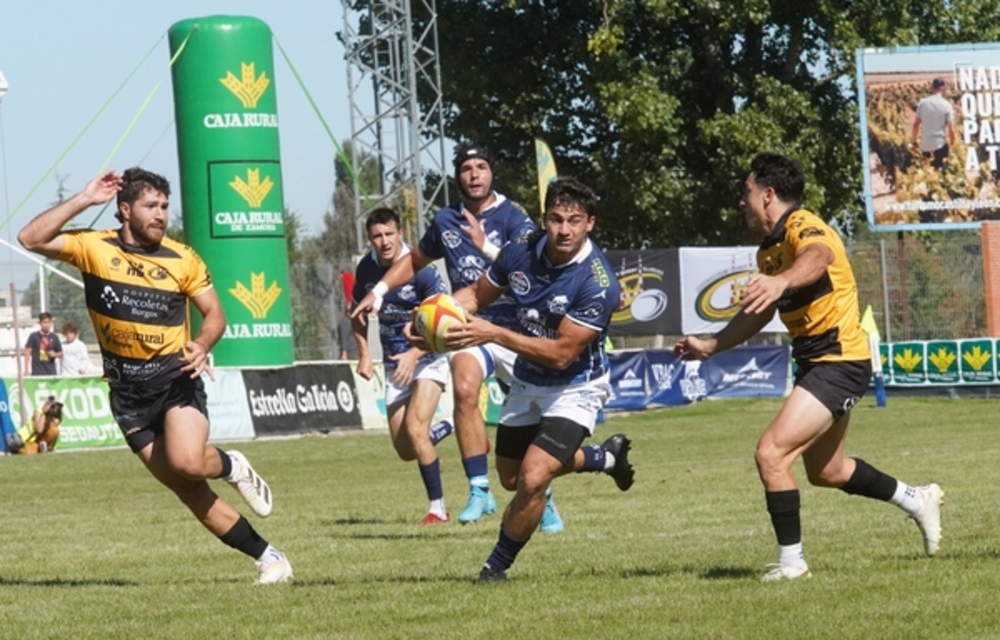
[59,229,212,394]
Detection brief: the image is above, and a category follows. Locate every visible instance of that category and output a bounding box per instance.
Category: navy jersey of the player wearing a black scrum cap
[420,193,538,331]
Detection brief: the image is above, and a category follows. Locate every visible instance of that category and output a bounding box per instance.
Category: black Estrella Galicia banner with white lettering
[243,363,362,436]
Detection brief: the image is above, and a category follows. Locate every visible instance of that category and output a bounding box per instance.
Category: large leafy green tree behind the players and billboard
[414,0,1000,248]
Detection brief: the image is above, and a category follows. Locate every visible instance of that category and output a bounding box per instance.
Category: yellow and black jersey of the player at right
[757,209,870,362]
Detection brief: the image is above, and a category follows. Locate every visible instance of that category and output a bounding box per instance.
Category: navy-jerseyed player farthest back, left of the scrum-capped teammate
[351,208,452,524]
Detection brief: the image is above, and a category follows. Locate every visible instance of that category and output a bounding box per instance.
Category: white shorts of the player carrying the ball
[500,374,611,436]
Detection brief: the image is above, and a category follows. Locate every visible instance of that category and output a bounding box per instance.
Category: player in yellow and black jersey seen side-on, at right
[674,153,943,582]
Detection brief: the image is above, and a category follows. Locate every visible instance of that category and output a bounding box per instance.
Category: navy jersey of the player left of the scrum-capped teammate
[351,250,448,372]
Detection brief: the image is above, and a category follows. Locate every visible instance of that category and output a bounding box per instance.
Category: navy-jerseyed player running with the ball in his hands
[430,178,635,582]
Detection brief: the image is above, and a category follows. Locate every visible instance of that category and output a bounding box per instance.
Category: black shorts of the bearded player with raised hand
[110,375,208,453]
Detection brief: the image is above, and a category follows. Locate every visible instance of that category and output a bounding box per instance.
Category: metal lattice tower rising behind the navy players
[341,0,448,250]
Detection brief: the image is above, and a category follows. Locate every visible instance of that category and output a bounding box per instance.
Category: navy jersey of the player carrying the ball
[486,231,618,386]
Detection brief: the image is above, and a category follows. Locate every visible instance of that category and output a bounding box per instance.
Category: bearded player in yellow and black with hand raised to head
[17,168,292,584]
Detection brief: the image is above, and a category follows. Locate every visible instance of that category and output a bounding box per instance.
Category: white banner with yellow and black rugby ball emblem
[678,247,785,334]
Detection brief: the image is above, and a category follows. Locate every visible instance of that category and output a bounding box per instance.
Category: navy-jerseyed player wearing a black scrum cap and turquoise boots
[351,142,563,533]
